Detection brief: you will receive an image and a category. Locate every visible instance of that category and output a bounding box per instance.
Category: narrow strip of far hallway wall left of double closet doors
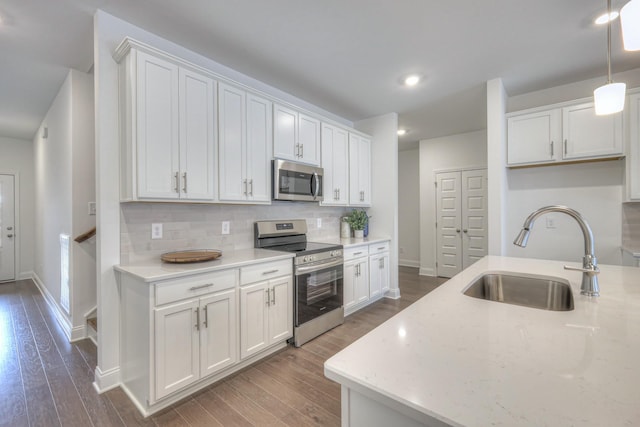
[398,147,420,267]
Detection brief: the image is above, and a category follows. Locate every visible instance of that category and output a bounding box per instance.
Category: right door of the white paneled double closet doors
[462,169,488,268]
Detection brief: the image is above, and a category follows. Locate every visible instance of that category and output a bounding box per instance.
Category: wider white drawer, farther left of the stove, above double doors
[155,269,238,305]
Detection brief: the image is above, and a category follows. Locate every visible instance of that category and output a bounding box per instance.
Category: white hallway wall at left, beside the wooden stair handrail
[33,70,96,339]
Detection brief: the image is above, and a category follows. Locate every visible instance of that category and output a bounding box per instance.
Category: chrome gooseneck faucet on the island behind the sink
[513,205,600,297]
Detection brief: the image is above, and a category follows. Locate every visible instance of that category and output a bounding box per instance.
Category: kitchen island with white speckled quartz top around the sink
[325,256,640,426]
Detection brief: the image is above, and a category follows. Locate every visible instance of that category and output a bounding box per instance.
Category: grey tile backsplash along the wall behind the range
[120,202,349,265]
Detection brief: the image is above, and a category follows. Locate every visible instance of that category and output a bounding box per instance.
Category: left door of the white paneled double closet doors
[436,172,462,277]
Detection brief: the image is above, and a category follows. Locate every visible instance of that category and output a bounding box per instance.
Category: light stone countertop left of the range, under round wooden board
[114,248,295,282]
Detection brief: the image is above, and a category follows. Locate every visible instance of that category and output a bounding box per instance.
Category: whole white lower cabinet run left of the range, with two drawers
[119,258,293,415]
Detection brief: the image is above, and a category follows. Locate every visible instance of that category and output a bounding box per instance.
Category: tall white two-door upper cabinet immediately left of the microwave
[218,83,272,203]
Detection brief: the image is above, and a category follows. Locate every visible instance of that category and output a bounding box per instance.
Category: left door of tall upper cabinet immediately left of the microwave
[218,83,248,201]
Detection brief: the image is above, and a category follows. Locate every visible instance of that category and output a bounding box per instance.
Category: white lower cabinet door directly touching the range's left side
[269,276,293,344]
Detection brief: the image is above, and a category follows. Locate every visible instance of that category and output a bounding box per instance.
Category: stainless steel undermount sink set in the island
[464,273,573,311]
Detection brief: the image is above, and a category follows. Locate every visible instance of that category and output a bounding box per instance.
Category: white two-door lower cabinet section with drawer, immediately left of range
[240,260,293,359]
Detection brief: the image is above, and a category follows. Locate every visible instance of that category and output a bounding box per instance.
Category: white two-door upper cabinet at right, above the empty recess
[507,102,624,166]
